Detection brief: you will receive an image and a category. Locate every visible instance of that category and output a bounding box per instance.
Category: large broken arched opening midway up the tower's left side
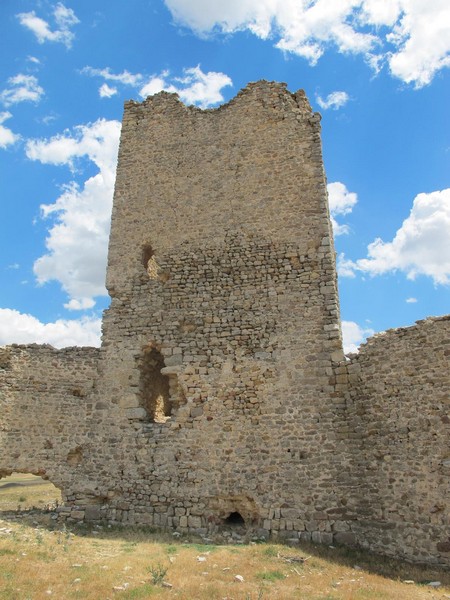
[139,347,172,423]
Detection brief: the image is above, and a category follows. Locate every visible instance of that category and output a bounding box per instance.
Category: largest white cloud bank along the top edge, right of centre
[165,0,450,87]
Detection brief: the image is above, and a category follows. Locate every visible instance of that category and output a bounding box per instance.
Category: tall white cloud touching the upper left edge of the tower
[27,119,120,310]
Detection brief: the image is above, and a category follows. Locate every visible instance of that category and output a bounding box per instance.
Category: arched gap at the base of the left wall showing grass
[0,473,62,514]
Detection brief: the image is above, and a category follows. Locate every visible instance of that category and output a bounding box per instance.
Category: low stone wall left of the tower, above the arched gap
[0,345,99,498]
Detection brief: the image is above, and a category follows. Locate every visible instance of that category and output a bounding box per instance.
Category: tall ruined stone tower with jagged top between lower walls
[90,82,349,541]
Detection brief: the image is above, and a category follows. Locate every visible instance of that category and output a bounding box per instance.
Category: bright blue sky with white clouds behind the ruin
[0,0,450,351]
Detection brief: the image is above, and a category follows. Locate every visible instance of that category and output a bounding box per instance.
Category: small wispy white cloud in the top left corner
[17,2,80,48]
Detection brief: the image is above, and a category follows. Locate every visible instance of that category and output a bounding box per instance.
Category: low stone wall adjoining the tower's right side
[348,317,450,564]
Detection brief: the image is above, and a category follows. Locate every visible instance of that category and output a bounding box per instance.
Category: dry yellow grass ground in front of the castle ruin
[0,480,450,600]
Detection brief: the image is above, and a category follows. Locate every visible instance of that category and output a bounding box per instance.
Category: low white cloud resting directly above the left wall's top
[0,308,101,348]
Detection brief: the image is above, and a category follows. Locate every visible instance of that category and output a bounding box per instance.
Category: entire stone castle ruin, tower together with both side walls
[0,81,450,565]
